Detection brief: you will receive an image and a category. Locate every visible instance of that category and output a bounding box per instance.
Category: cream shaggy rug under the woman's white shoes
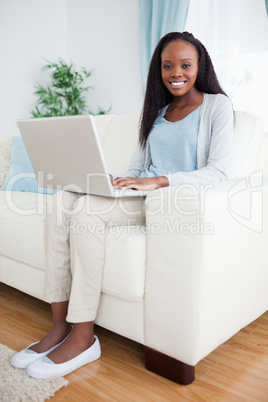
[0,344,68,402]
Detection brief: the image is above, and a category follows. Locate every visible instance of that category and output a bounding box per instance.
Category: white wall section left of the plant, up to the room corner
[0,0,67,140]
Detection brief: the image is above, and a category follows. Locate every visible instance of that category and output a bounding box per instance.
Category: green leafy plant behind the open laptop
[31,59,111,117]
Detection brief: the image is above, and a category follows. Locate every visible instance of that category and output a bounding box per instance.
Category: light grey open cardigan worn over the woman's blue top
[124,94,233,185]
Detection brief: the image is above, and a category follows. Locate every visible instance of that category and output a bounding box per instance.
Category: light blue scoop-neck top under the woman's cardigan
[140,105,201,177]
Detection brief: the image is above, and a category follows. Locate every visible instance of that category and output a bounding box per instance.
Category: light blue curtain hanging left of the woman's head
[139,0,190,89]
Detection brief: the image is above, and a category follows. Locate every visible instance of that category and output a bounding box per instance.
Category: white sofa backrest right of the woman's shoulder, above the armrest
[230,111,263,178]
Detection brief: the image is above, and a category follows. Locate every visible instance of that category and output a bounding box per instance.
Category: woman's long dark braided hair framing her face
[139,32,227,147]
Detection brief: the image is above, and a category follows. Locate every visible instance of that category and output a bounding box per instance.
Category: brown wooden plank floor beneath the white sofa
[0,283,268,402]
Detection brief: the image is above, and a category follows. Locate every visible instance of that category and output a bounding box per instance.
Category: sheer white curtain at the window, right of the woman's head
[185,0,268,130]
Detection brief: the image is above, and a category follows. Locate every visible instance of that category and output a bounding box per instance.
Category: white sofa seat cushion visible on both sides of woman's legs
[0,191,146,301]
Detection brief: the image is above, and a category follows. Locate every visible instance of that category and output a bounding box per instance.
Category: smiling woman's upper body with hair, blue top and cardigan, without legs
[132,32,233,185]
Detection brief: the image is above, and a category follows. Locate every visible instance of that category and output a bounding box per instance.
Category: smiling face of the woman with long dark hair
[161,40,198,96]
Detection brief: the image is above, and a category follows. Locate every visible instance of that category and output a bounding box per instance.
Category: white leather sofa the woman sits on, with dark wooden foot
[0,112,268,384]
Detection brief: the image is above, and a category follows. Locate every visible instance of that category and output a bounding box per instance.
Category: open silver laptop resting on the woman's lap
[17,115,149,197]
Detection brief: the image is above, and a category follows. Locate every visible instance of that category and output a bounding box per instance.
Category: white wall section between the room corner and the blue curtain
[68,0,143,114]
